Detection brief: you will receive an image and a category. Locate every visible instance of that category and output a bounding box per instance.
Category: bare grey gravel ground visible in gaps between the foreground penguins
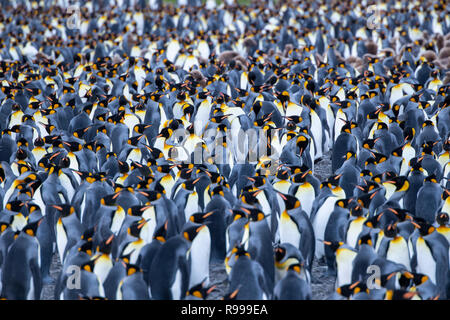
[41,153,335,300]
